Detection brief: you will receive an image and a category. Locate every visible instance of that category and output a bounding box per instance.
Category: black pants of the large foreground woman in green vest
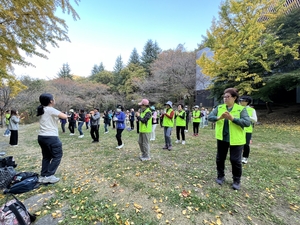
[216,140,244,182]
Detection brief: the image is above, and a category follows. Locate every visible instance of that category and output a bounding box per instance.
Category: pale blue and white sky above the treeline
[14,0,222,79]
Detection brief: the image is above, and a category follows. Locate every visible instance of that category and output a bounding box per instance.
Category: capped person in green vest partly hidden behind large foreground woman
[239,96,257,164]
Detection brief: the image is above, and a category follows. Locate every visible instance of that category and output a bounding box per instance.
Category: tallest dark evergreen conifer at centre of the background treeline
[141,39,161,75]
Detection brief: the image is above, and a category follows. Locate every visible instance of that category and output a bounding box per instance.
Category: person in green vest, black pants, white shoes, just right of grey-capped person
[175,104,186,145]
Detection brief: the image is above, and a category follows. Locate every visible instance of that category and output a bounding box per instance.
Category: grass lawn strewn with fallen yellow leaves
[0,123,300,225]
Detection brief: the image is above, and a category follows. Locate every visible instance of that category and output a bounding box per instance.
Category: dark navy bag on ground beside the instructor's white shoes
[4,172,39,194]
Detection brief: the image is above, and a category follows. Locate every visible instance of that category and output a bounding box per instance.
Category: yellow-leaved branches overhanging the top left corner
[0,0,79,77]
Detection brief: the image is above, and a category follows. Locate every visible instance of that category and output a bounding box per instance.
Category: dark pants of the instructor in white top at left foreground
[38,135,63,177]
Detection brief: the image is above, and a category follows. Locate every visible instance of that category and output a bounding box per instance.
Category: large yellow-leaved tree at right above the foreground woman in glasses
[197,0,297,97]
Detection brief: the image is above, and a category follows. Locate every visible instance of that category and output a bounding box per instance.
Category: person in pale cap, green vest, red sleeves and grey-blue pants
[162,101,174,151]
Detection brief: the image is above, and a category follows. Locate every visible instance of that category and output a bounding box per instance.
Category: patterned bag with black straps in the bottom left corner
[0,195,36,225]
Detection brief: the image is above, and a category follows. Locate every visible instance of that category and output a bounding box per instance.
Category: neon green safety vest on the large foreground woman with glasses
[216,103,246,145]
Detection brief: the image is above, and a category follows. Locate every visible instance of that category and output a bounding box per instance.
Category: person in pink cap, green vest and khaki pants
[136,99,155,161]
